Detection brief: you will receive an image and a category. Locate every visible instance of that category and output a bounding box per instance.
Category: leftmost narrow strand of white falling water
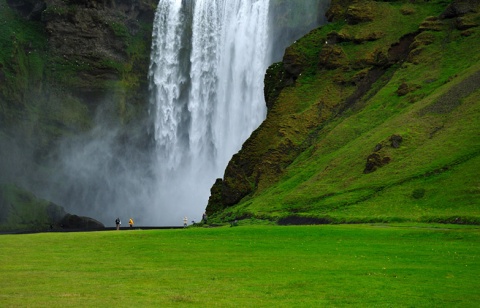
[150,0,187,170]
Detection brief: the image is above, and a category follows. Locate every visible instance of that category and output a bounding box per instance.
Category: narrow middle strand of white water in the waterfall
[188,0,223,171]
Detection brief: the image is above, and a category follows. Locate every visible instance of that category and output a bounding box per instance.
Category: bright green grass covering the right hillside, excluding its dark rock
[216,1,480,223]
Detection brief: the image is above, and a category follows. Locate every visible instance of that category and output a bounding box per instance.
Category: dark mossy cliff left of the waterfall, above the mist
[0,0,156,136]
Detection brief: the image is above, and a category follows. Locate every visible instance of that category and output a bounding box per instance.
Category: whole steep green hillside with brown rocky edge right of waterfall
[207,0,480,223]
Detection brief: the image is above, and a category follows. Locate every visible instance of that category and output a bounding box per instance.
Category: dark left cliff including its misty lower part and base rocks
[0,0,157,229]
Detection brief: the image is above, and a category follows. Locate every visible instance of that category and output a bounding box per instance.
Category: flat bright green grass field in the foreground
[0,224,480,307]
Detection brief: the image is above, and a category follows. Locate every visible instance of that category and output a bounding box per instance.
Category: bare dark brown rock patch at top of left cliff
[42,0,153,60]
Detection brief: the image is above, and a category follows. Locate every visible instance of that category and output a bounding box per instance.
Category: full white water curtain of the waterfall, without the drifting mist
[150,0,269,223]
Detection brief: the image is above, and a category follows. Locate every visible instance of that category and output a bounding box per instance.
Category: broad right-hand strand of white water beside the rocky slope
[214,0,271,169]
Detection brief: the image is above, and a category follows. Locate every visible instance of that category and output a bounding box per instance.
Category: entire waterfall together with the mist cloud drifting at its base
[22,0,330,226]
